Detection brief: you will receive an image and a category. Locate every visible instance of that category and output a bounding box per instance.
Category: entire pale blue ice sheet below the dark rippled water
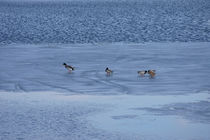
[0,43,210,140]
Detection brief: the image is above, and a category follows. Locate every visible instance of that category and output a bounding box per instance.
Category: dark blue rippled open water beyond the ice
[0,0,210,44]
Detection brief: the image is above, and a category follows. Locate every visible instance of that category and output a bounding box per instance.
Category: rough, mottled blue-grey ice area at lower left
[0,92,144,140]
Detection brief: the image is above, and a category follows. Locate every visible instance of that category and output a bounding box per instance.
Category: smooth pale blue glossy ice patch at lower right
[88,91,210,140]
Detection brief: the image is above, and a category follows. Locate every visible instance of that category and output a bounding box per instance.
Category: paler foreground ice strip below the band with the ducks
[0,92,210,140]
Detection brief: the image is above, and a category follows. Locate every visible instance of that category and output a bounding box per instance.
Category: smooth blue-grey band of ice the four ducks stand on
[0,43,210,95]
